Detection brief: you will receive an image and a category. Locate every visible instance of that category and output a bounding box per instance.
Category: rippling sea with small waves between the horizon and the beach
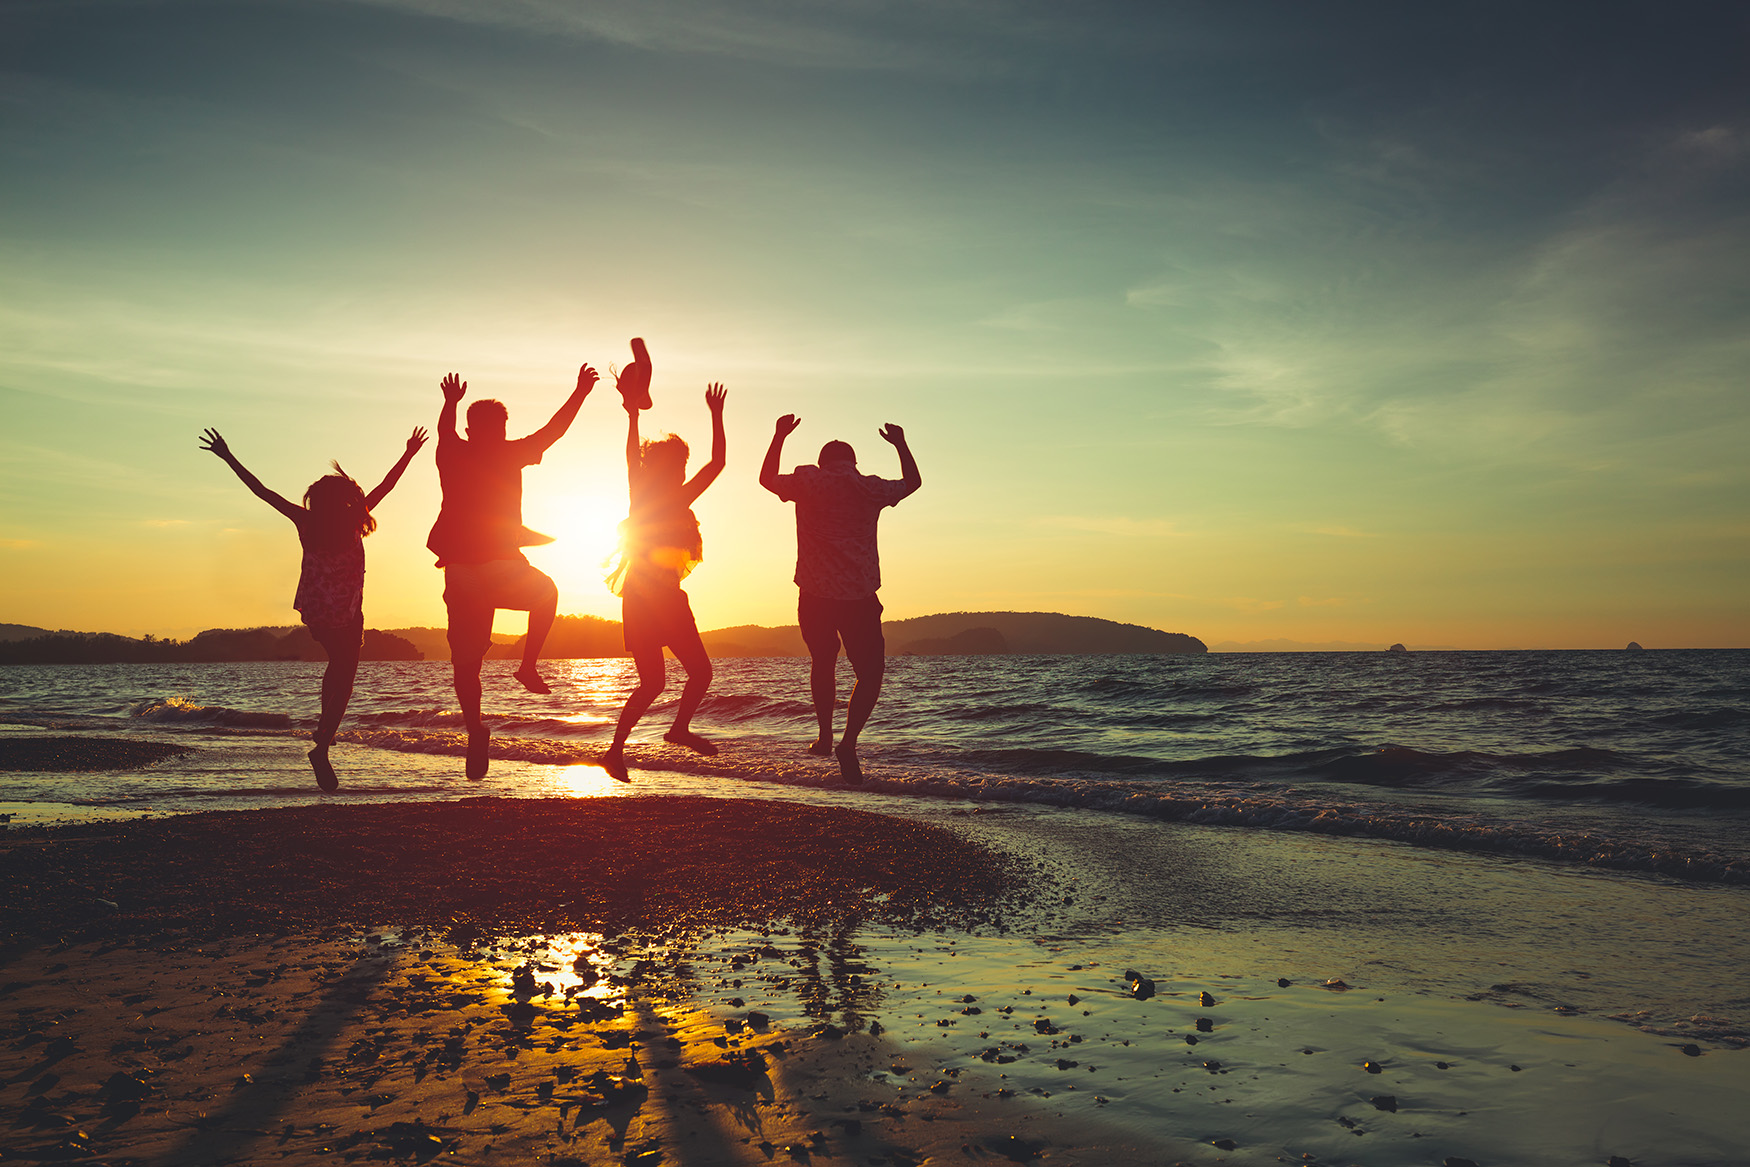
[0,651,1750,884]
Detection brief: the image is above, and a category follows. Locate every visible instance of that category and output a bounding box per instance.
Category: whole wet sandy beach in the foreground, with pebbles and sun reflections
[0,783,1750,1167]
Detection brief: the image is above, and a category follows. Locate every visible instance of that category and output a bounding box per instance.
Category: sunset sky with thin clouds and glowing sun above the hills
[0,0,1750,647]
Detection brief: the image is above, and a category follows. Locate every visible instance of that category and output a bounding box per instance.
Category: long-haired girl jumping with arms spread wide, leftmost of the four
[201,429,425,793]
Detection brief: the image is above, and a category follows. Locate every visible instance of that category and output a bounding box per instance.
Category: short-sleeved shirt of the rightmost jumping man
[775,462,910,600]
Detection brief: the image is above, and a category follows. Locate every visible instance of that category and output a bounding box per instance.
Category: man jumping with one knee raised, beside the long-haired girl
[425,366,597,779]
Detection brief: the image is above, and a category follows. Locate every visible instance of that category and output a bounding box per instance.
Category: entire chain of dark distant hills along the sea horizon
[0,612,1208,665]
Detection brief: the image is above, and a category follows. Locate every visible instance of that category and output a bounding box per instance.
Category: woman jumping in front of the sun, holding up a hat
[602,351,726,782]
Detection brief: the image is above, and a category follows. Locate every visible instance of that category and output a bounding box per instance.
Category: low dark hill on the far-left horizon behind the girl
[0,625,422,665]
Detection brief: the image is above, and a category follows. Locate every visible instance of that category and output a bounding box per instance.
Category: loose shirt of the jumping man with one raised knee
[425,436,553,567]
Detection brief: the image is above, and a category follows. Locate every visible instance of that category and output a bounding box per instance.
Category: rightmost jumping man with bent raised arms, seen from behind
[760,413,924,786]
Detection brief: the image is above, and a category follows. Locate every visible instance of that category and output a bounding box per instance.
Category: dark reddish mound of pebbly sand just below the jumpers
[0,796,1020,940]
